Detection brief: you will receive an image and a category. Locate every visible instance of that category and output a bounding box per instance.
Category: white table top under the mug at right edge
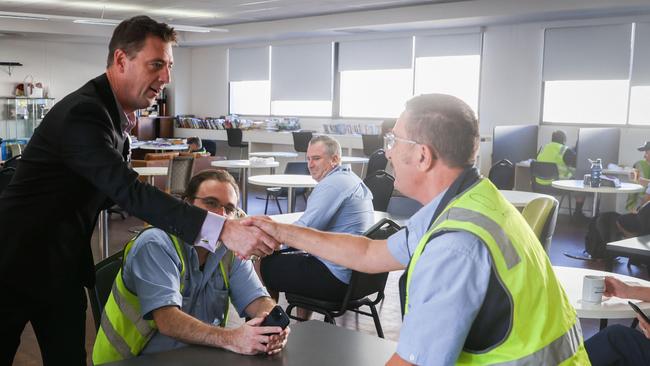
[553,266,650,319]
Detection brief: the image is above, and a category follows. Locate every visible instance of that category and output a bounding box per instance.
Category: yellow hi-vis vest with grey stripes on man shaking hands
[404,178,589,365]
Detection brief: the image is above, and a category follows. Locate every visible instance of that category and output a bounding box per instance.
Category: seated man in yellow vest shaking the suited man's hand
[245,94,589,365]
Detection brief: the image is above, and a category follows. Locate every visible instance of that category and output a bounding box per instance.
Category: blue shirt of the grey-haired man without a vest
[294,166,374,283]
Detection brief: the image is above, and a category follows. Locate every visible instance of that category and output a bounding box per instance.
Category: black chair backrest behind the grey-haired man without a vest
[342,218,401,304]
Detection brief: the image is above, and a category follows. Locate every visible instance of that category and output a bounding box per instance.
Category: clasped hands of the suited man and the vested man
[220,216,284,261]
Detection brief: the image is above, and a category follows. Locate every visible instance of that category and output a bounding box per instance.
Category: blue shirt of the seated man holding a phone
[123,228,269,353]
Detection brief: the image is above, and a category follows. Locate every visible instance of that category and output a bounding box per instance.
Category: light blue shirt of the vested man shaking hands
[388,192,492,365]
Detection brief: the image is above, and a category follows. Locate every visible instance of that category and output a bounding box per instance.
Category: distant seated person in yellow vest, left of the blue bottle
[535,130,585,218]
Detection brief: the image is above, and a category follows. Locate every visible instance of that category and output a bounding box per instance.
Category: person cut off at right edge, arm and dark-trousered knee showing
[585,277,650,366]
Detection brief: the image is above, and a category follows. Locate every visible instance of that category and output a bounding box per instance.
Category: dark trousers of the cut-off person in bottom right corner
[585,324,650,366]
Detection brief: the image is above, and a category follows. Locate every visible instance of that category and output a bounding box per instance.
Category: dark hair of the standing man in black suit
[106,15,176,67]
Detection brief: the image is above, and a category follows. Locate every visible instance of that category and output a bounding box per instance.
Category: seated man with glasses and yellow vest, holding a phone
[93,170,290,364]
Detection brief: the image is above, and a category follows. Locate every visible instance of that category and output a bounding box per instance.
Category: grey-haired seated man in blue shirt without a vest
[260,135,373,319]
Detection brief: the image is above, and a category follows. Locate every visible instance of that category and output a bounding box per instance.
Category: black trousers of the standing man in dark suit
[0,285,86,366]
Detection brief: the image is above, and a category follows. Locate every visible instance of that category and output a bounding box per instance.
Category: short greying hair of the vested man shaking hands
[405,94,479,168]
